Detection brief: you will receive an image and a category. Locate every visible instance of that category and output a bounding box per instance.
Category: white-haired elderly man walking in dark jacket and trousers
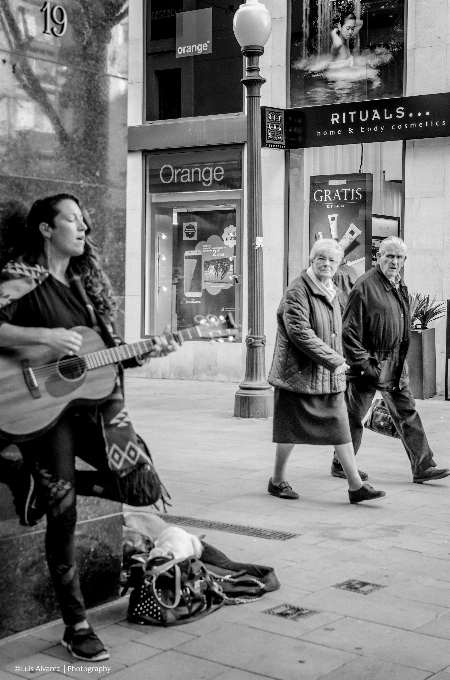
[331,236,450,484]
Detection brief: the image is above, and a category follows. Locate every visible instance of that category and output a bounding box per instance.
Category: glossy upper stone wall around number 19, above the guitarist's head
[0,0,127,322]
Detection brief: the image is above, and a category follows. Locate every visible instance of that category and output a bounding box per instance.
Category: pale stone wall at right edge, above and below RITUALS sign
[405,0,450,394]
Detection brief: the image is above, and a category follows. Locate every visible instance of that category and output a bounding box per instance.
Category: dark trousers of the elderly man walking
[345,380,436,475]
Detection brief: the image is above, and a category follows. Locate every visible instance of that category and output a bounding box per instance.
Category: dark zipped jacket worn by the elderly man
[342,265,411,389]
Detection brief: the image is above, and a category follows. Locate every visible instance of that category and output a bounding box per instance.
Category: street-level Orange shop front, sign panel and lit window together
[143,146,242,335]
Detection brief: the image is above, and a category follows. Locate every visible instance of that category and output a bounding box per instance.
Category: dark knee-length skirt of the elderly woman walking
[273,387,352,445]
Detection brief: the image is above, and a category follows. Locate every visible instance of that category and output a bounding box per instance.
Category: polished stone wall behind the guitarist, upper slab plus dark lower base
[0,0,128,637]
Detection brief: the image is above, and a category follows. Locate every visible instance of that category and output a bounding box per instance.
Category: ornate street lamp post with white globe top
[233,0,273,418]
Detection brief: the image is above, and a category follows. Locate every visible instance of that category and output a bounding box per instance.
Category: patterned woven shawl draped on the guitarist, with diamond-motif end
[0,257,148,477]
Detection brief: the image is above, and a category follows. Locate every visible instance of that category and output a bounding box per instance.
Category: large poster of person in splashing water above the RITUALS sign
[291,0,406,107]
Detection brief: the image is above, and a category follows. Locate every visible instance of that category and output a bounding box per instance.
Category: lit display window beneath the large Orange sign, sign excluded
[146,203,240,333]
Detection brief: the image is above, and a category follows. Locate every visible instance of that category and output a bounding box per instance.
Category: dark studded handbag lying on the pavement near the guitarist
[128,557,224,627]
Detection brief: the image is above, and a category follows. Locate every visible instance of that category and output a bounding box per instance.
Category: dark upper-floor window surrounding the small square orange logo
[146,0,244,120]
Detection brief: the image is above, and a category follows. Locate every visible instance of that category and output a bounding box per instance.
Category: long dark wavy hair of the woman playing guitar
[2,193,117,321]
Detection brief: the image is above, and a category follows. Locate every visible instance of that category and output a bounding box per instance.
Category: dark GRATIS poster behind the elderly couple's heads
[309,172,373,280]
